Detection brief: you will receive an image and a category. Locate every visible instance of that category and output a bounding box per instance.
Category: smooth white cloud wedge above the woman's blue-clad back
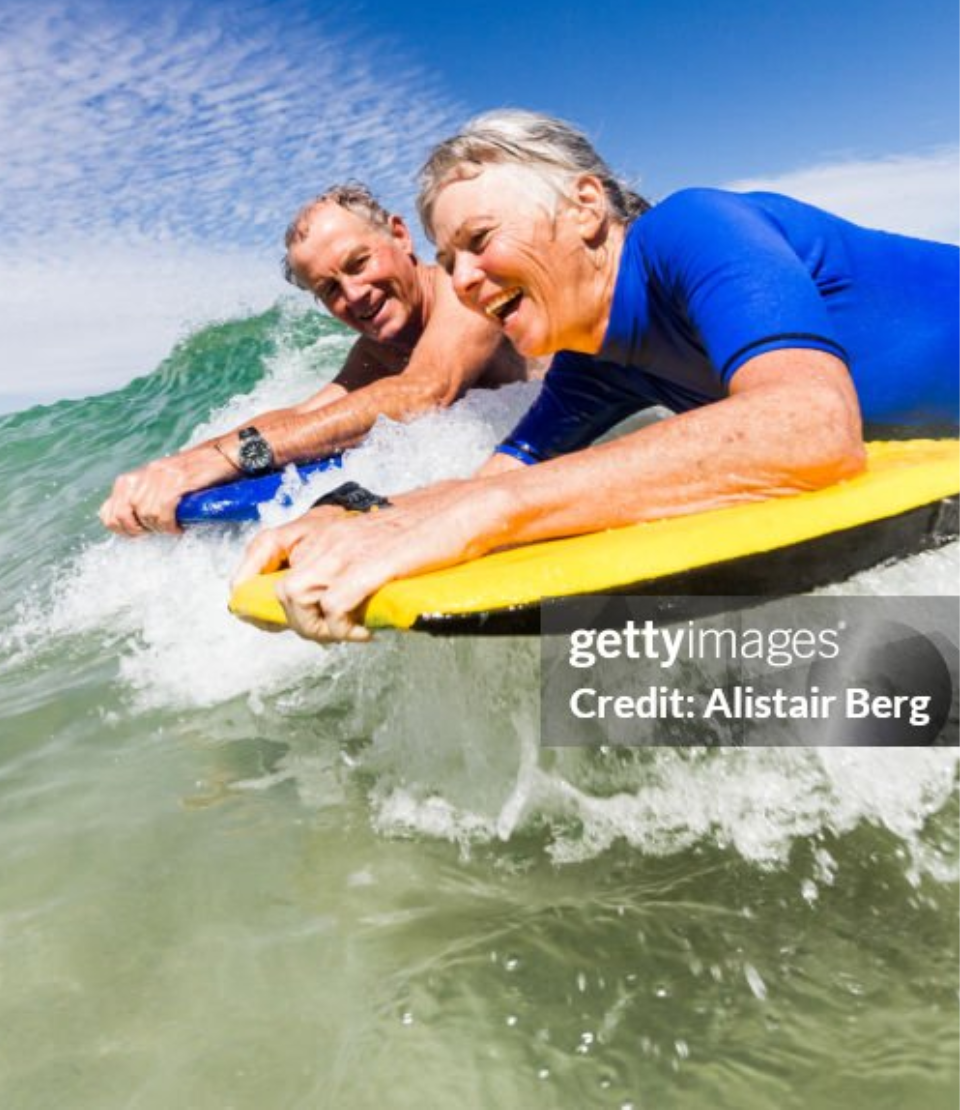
[726,148,960,243]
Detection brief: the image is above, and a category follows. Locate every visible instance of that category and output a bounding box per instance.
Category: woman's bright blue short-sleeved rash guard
[497,189,960,463]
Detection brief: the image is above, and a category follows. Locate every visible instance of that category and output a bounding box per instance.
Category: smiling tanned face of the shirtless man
[287,203,425,346]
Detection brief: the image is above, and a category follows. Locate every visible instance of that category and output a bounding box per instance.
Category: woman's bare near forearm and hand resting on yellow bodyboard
[238,350,865,640]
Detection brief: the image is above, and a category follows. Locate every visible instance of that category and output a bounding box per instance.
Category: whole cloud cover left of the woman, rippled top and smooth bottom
[0,0,454,408]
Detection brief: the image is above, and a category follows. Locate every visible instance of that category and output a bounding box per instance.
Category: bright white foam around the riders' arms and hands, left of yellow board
[11,357,537,708]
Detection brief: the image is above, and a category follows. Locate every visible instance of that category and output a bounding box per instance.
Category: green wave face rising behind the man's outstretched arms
[0,306,341,589]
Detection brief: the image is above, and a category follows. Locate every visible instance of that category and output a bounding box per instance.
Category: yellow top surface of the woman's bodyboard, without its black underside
[230,440,960,628]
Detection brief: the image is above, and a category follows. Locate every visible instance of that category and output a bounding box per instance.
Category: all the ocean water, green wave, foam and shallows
[0,309,960,1110]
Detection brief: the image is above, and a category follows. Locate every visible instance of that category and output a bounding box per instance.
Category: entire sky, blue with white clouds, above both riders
[0,0,960,406]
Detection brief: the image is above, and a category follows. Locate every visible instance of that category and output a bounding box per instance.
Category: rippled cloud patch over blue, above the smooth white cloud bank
[0,0,461,243]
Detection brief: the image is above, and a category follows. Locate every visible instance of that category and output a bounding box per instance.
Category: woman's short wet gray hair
[416,108,650,240]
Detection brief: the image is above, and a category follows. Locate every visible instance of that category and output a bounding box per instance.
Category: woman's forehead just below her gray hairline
[431,162,563,249]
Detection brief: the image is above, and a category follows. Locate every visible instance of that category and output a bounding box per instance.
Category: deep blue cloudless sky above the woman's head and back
[358,0,958,193]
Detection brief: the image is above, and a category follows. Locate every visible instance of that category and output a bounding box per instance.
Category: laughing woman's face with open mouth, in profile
[433,165,599,357]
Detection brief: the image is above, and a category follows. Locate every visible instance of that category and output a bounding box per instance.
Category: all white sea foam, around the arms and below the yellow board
[11,340,958,870]
